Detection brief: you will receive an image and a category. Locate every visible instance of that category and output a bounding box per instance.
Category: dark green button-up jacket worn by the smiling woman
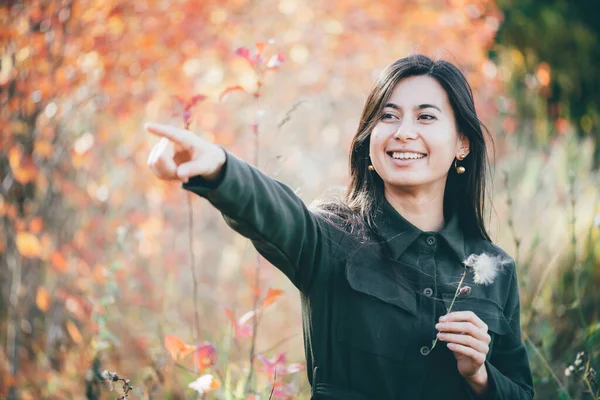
[183,153,534,400]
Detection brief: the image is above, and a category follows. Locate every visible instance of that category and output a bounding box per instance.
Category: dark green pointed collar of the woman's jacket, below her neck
[375,199,466,262]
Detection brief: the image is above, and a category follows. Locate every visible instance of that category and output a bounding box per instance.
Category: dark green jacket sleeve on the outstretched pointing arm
[182,151,343,292]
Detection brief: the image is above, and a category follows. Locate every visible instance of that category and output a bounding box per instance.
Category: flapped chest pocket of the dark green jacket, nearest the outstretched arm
[335,251,417,362]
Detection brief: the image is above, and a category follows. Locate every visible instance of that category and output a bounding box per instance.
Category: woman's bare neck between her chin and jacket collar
[385,187,445,232]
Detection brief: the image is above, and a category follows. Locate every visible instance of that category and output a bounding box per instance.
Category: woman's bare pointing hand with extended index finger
[144,122,226,182]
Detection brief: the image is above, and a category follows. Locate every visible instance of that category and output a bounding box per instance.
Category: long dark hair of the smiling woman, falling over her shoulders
[320,54,493,241]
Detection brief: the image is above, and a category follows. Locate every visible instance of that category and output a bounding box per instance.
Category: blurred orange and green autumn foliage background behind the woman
[0,0,600,399]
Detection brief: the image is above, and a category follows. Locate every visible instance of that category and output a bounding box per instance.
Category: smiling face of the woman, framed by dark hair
[369,75,469,190]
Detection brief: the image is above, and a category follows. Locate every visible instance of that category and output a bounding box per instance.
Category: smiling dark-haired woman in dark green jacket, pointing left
[145,55,534,400]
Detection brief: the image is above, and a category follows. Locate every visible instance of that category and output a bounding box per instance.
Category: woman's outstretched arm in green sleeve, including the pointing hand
[146,120,343,292]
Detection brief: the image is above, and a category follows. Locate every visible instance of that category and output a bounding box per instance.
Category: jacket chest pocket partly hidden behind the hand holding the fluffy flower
[442,293,513,360]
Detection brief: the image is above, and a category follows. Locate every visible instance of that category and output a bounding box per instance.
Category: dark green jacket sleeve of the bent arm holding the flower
[467,263,534,400]
